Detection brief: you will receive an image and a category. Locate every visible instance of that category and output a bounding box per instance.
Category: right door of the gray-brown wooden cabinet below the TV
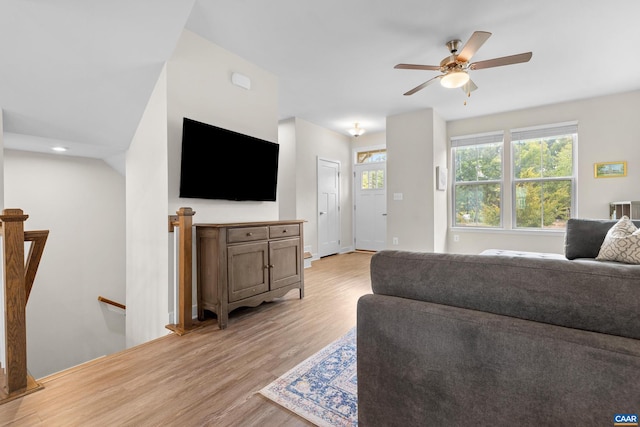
[269,238,302,289]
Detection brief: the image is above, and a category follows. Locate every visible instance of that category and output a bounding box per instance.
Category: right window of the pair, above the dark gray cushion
[511,124,578,229]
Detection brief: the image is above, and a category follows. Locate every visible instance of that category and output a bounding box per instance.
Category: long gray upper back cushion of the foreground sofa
[371,250,640,339]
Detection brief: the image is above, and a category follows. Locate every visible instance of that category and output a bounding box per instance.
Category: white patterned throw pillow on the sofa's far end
[596,215,640,264]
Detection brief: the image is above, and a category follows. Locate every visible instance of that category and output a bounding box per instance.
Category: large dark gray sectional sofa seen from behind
[357,220,640,427]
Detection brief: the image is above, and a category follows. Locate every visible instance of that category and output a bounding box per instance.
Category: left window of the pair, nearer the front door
[451,132,504,227]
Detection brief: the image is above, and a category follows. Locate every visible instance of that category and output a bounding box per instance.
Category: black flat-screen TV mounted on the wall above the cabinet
[180,117,280,201]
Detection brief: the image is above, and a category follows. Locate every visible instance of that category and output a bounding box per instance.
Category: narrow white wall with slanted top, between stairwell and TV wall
[126,67,170,347]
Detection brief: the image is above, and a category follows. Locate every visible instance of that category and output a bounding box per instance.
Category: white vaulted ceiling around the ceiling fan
[0,0,640,158]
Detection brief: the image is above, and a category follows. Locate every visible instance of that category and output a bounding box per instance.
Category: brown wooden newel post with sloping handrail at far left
[0,209,49,404]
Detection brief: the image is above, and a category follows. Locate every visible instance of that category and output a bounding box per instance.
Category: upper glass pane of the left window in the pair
[455,143,502,182]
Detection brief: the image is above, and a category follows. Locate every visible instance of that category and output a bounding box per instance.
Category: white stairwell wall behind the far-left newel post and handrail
[4,150,125,378]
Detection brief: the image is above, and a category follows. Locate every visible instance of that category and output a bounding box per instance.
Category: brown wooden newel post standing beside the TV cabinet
[166,208,200,335]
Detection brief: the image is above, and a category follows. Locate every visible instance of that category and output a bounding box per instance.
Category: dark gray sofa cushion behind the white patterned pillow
[564,218,640,259]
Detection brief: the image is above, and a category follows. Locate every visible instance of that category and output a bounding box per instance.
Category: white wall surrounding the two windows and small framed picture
[447,91,640,253]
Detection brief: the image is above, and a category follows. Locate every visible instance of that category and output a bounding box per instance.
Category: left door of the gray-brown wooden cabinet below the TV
[227,242,269,302]
